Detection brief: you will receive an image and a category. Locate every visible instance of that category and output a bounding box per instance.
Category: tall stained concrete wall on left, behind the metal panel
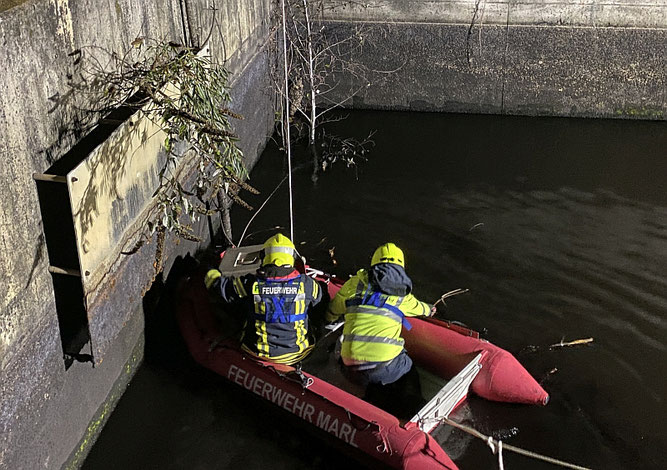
[0,0,273,468]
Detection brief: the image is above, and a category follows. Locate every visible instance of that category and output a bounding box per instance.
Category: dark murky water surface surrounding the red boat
[85,112,667,469]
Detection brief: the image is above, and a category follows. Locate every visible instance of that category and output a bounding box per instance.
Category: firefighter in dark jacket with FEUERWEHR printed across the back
[205,233,322,364]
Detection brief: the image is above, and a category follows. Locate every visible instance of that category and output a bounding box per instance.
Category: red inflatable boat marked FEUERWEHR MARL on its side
[177,246,548,469]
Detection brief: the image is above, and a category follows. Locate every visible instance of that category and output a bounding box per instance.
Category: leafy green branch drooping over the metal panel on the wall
[71,38,258,240]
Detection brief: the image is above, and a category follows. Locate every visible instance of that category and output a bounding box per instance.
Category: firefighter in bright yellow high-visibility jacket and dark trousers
[327,243,435,417]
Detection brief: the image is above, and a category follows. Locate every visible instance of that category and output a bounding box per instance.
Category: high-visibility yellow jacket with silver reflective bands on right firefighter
[327,265,431,365]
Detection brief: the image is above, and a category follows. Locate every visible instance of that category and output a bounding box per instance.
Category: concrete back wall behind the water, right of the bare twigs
[326,0,667,119]
